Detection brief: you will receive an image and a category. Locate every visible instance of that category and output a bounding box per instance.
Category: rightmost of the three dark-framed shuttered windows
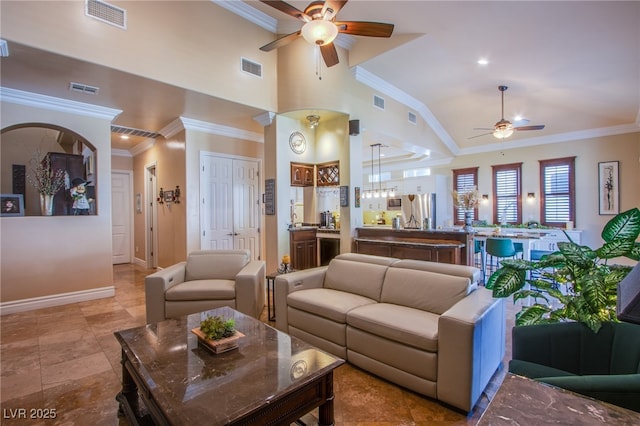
[540,157,575,226]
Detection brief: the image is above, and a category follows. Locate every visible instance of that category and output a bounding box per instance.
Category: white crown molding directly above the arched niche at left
[0,87,122,121]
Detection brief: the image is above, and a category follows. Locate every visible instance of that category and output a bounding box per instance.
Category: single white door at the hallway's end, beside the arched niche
[111,171,133,265]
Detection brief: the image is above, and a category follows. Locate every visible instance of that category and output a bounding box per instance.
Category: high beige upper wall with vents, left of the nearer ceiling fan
[0,0,277,112]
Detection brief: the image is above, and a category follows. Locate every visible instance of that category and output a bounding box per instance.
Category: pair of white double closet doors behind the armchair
[200,153,261,259]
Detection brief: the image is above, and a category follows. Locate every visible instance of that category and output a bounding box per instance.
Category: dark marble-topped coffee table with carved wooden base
[115,308,344,425]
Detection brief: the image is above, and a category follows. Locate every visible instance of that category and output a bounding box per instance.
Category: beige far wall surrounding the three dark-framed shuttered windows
[434,132,640,248]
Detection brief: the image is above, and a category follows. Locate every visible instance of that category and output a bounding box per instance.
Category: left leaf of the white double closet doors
[200,155,234,250]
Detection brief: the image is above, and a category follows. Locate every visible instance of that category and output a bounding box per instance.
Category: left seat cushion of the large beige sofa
[287,288,376,324]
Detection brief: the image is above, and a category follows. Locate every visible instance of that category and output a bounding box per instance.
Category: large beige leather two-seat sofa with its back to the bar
[275,253,506,412]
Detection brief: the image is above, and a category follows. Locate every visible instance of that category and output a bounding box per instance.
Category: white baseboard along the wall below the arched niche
[0,286,116,316]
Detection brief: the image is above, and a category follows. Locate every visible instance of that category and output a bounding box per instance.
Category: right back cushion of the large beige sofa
[380,268,471,314]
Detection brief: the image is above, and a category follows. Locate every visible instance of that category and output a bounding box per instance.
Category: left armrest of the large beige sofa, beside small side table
[273,266,327,333]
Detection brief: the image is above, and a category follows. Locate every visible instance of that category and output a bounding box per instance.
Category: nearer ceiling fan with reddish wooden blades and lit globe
[260,0,393,67]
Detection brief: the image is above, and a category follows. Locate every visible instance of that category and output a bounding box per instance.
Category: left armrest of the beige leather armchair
[144,262,187,324]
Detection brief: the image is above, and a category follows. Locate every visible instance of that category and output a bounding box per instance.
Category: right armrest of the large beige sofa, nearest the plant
[437,287,506,412]
